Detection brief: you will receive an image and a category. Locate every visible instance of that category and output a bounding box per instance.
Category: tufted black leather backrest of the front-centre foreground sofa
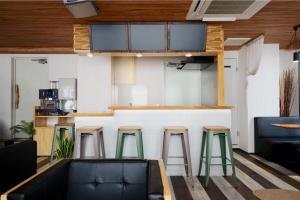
[68,160,148,200]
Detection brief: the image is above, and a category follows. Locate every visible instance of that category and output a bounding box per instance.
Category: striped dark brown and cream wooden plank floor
[38,150,300,200]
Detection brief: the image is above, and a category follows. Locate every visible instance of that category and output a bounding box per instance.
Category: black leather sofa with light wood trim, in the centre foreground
[5,160,164,200]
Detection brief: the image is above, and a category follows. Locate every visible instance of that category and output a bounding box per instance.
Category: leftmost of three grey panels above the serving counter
[90,24,128,51]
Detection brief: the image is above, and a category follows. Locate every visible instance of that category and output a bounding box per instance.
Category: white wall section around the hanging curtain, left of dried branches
[237,44,280,153]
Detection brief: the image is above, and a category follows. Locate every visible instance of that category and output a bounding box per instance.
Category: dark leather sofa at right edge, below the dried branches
[254,117,300,173]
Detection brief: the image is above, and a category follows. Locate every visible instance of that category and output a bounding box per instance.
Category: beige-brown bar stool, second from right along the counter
[162,126,192,177]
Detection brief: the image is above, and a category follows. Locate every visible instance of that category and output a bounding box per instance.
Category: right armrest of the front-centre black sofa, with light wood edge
[148,160,171,200]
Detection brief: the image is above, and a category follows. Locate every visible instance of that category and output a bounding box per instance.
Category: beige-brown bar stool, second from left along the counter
[73,126,106,159]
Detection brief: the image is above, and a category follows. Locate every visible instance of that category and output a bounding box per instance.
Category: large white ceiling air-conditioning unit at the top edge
[186,0,270,21]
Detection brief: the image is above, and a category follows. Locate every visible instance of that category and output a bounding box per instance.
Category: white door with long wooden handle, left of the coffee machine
[13,58,49,131]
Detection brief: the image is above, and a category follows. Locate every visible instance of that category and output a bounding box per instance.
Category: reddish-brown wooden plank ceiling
[0,0,300,53]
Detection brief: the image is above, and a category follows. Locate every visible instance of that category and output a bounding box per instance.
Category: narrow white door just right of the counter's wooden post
[224,58,238,145]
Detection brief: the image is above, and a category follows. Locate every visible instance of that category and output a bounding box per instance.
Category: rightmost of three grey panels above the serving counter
[168,24,207,51]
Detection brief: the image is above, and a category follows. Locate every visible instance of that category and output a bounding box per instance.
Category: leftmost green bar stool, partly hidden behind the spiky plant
[50,123,75,161]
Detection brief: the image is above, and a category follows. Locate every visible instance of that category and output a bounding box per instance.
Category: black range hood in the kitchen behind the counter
[167,56,215,71]
